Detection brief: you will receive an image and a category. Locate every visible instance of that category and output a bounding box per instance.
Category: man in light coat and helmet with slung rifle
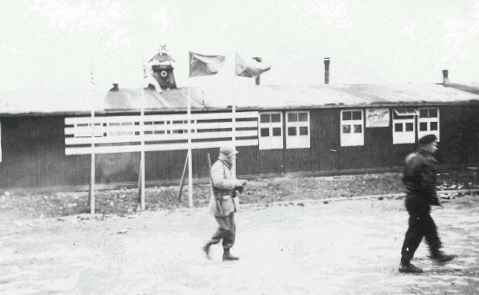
[203,146,246,261]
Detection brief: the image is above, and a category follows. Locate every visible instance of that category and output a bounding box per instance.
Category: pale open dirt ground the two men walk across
[0,196,479,295]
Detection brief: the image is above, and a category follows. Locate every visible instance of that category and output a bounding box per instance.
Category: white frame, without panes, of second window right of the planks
[285,111,311,149]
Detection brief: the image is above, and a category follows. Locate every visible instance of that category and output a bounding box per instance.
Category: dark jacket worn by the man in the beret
[402,148,439,205]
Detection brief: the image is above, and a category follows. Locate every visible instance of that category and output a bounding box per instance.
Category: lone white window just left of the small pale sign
[341,110,364,146]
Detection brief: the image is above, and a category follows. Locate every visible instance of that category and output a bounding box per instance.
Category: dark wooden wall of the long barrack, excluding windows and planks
[0,105,479,188]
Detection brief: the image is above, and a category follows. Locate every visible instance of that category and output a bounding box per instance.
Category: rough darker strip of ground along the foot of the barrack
[0,171,479,221]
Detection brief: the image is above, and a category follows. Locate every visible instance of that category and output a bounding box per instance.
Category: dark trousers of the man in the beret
[401,195,442,264]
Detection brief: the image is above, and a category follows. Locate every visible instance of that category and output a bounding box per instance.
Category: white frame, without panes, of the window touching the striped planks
[258,111,284,150]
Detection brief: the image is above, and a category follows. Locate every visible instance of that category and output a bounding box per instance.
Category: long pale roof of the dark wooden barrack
[0,83,479,114]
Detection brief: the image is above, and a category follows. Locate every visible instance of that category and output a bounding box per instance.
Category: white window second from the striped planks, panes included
[286,112,309,149]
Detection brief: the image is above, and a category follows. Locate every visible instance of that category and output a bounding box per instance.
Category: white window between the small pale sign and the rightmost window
[393,109,417,144]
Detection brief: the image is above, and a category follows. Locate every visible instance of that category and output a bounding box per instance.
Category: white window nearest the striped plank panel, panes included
[258,112,283,150]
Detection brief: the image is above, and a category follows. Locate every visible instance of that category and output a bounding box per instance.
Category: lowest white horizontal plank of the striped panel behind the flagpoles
[65,139,258,155]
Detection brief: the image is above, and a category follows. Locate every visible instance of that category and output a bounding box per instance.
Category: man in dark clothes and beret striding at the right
[399,134,456,273]
